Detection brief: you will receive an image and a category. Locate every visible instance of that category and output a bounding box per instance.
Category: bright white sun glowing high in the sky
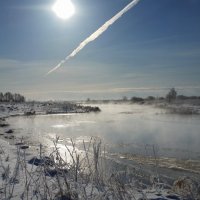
[52,0,75,19]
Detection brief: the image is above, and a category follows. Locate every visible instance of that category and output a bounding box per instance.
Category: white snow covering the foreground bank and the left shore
[0,103,200,200]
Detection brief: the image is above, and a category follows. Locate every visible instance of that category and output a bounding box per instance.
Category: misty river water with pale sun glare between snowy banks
[8,104,200,159]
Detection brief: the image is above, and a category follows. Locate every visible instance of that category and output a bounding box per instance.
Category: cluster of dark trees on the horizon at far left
[0,92,25,102]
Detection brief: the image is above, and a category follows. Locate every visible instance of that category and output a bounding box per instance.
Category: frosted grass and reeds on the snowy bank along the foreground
[0,138,198,200]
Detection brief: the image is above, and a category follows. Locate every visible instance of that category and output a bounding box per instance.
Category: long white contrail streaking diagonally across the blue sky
[46,0,140,75]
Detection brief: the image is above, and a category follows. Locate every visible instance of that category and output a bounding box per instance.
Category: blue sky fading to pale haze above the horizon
[0,0,200,100]
